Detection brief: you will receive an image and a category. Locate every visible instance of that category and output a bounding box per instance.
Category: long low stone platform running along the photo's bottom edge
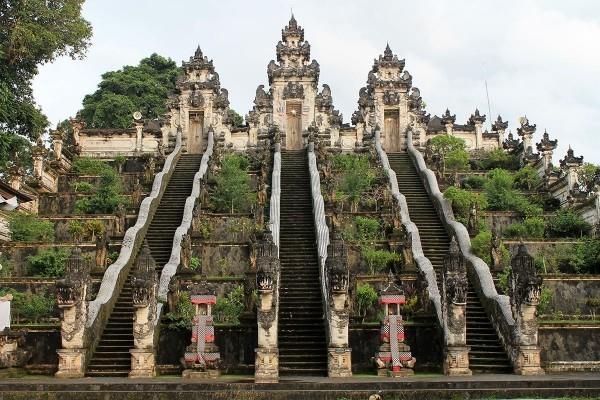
[0,374,600,400]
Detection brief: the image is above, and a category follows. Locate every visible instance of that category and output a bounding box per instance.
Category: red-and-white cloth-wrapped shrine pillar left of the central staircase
[181,282,221,379]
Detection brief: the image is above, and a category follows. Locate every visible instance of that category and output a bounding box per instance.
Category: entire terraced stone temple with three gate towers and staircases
[0,15,600,396]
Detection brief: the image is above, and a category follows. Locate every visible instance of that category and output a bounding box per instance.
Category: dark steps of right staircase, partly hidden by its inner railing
[387,153,512,373]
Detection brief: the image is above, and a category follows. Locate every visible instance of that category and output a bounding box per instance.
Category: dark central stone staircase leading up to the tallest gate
[279,150,327,376]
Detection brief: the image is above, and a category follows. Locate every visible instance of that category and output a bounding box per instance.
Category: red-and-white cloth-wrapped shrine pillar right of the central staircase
[375,271,417,377]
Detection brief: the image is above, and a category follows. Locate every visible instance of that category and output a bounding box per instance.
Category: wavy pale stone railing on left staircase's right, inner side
[155,130,214,304]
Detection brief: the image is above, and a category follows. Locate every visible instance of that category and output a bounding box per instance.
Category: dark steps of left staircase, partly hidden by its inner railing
[87,154,202,377]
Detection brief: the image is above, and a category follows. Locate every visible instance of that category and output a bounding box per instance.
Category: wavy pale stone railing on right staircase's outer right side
[406,128,519,365]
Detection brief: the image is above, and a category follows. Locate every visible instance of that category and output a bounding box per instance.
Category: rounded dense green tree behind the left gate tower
[81,53,180,128]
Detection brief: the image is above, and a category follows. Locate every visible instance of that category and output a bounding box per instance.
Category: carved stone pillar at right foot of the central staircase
[325,229,352,378]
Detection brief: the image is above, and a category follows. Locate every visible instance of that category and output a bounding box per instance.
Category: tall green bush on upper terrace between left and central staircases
[212,154,256,213]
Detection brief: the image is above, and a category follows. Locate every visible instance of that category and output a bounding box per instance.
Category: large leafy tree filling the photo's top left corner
[0,0,92,139]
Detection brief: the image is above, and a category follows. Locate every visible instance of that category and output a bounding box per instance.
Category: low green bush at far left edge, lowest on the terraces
[0,289,56,324]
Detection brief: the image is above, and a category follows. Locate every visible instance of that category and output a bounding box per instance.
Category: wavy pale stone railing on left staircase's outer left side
[86,131,181,350]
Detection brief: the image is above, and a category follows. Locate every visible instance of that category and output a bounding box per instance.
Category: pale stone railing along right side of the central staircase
[308,143,331,330]
